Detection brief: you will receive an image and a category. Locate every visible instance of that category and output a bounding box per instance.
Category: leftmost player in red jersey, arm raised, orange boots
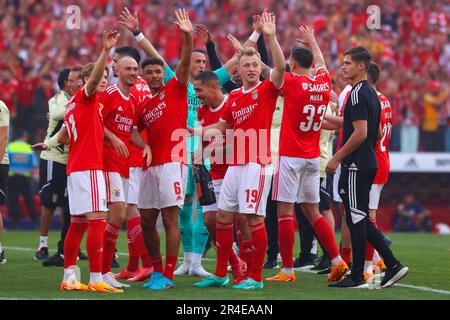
[56,31,123,293]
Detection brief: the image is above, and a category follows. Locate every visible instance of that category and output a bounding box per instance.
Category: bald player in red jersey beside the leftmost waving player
[96,56,151,288]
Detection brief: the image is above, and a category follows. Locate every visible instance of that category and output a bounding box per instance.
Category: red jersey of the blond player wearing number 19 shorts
[220,79,281,165]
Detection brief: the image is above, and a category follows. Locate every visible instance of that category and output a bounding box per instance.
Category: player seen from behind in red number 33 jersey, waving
[266,27,348,282]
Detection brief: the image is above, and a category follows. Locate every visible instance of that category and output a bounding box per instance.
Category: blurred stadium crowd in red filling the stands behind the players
[0,0,450,152]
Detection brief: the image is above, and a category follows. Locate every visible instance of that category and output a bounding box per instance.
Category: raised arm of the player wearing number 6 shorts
[175,9,194,84]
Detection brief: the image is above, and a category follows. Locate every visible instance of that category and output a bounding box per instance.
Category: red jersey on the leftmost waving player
[64,86,104,175]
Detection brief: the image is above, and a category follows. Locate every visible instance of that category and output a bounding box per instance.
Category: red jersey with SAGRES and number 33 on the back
[279,68,331,159]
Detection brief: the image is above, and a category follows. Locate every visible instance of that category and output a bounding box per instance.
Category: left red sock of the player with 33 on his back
[278,215,295,268]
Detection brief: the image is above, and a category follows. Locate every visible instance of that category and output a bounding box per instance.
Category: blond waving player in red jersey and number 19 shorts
[194,12,286,290]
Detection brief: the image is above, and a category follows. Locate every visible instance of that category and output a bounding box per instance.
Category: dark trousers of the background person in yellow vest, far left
[7,175,37,225]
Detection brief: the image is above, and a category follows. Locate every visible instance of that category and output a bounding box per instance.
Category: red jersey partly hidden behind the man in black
[373,92,392,184]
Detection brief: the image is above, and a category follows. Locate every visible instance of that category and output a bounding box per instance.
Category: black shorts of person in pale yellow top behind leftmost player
[39,159,67,208]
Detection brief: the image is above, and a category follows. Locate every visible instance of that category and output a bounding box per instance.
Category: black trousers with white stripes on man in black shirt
[339,168,398,281]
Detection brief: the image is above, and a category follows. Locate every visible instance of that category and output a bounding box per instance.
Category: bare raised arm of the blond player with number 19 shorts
[261,12,286,88]
